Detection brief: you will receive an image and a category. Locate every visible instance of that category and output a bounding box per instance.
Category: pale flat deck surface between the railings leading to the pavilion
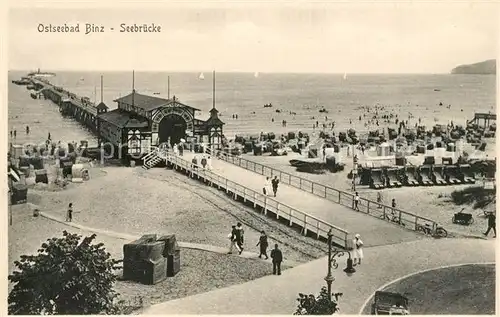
[182,152,426,246]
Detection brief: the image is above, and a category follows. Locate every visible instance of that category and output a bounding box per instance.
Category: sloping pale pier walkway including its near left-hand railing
[150,152,426,249]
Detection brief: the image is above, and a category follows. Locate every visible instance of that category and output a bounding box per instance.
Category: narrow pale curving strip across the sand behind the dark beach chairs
[40,212,297,266]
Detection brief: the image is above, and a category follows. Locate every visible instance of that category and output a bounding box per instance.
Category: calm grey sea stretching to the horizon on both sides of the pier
[8,71,496,144]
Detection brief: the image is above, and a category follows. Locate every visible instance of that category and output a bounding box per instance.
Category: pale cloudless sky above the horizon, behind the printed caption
[8,2,500,73]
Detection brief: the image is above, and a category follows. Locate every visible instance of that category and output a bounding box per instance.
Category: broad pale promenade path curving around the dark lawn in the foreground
[141,239,495,315]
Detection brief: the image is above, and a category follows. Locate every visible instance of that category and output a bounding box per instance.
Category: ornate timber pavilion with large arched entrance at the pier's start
[98,89,224,157]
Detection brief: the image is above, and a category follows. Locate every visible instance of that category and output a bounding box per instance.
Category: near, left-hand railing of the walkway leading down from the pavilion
[156,149,353,249]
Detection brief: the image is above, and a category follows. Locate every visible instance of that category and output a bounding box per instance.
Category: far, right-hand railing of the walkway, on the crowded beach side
[203,149,438,232]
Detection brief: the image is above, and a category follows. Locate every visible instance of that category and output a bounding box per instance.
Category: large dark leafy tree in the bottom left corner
[8,231,119,315]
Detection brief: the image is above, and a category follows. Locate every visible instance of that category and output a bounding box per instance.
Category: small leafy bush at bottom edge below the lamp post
[294,286,342,315]
